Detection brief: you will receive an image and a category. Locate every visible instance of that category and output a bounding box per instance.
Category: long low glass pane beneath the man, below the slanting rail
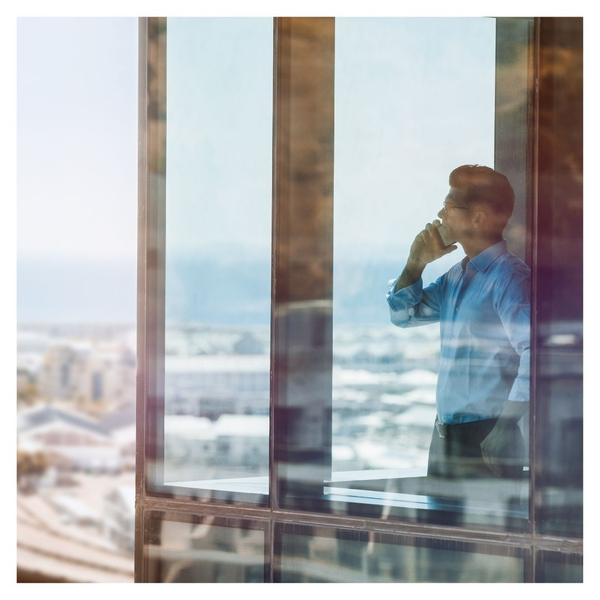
[277,526,524,583]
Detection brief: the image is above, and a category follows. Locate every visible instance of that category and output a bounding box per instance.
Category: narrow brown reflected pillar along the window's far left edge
[136,17,167,498]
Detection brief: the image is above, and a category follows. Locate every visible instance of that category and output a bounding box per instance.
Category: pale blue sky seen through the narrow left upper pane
[166,18,273,260]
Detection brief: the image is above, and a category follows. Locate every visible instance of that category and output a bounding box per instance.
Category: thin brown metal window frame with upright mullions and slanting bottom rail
[135,18,583,582]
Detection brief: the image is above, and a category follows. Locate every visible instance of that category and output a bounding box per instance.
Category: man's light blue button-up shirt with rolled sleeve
[387,240,531,423]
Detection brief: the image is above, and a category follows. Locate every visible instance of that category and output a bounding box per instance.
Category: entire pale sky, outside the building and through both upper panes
[17,17,495,321]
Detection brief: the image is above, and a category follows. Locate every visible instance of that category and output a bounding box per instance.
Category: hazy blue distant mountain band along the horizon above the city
[17,252,462,325]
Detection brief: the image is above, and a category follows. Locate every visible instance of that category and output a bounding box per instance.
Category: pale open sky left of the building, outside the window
[17,18,138,324]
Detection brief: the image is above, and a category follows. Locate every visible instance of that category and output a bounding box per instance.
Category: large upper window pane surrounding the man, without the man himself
[275,19,533,530]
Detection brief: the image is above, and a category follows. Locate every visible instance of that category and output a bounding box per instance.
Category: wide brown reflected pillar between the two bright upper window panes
[272,18,334,506]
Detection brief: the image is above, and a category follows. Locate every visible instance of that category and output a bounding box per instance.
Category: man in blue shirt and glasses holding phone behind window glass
[387,165,530,478]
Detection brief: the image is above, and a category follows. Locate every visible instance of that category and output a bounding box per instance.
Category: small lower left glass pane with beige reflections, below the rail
[145,513,265,583]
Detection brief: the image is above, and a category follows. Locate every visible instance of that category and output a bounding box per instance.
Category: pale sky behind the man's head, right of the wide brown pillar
[334,18,496,276]
